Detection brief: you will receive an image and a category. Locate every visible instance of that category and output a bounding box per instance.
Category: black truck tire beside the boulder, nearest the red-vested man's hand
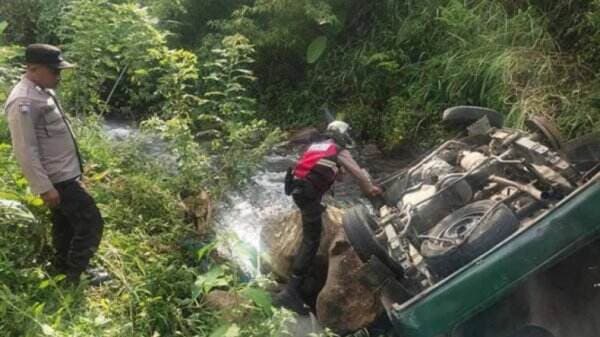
[342,205,404,277]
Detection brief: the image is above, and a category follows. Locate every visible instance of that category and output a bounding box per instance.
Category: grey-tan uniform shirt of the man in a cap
[5,77,82,194]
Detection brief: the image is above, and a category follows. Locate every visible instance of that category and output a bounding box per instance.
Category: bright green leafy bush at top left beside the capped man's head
[60,0,198,118]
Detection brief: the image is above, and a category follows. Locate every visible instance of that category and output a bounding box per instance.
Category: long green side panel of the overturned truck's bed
[388,175,600,337]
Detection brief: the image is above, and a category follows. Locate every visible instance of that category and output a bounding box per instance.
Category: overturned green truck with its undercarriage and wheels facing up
[343,106,600,337]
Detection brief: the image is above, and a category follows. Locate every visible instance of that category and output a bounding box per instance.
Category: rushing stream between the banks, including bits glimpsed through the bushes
[105,121,408,337]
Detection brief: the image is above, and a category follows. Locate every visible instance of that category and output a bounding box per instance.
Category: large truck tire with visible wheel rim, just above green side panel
[421,200,519,278]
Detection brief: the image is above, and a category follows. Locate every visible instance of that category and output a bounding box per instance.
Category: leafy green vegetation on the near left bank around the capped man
[0,0,288,336]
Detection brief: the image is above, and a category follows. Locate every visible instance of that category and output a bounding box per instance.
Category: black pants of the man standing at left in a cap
[51,180,104,275]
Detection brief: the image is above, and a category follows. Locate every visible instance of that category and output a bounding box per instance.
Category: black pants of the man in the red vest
[292,181,325,277]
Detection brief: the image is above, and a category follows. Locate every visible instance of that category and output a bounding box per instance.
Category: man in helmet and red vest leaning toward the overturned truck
[274,121,382,314]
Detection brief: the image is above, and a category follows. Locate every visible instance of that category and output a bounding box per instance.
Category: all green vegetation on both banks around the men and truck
[0,0,600,337]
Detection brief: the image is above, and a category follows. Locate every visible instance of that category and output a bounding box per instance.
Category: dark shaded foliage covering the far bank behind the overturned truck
[136,0,600,147]
